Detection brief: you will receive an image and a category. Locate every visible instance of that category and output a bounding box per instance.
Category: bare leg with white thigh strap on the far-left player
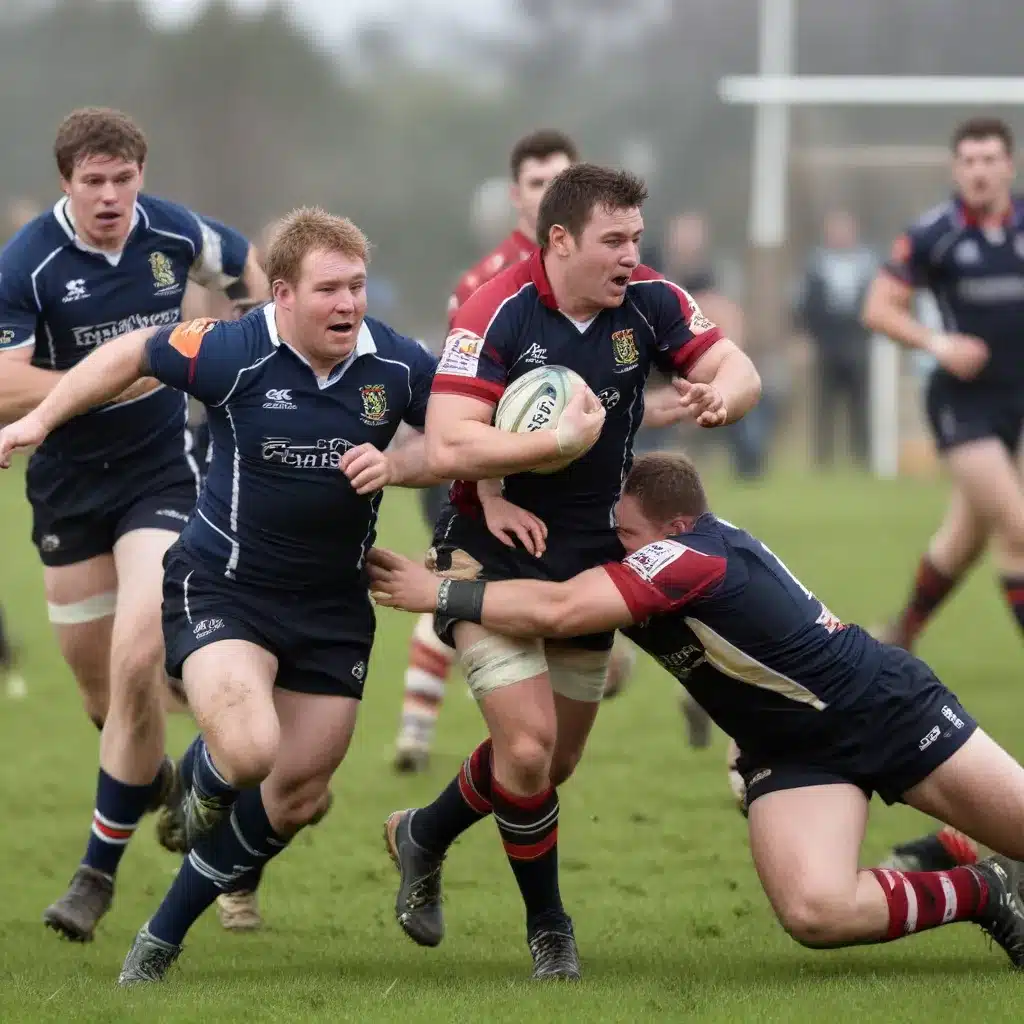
[43,554,118,729]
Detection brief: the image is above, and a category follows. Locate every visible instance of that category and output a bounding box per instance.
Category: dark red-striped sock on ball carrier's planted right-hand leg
[490,779,565,929]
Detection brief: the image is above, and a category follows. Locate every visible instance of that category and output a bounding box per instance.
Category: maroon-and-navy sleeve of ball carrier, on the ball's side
[431,266,529,403]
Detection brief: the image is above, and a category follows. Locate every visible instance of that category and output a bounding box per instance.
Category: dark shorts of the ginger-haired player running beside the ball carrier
[163,542,375,699]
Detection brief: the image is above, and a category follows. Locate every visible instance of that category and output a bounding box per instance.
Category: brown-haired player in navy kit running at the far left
[0,109,265,941]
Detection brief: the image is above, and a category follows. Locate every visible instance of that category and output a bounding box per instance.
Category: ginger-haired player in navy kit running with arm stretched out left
[0,209,444,984]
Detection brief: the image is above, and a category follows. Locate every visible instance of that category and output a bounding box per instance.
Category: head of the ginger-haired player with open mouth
[266,207,370,365]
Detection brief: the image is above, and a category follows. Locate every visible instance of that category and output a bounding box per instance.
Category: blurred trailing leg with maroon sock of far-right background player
[882,480,988,650]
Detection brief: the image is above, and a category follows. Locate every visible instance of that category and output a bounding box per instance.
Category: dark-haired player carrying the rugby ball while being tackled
[387,164,760,979]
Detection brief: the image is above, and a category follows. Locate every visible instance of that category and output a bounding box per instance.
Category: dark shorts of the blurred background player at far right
[925,371,1024,455]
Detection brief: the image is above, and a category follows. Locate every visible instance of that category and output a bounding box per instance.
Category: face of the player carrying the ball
[565,206,643,309]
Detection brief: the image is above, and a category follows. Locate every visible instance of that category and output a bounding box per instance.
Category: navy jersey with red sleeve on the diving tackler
[604,514,883,748]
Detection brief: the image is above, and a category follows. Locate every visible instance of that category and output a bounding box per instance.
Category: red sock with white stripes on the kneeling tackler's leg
[871,867,988,942]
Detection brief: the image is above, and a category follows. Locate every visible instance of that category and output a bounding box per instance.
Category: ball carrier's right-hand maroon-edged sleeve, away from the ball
[630,266,724,377]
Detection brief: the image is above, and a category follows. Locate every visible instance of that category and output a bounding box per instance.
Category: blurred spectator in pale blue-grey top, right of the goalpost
[796,210,878,467]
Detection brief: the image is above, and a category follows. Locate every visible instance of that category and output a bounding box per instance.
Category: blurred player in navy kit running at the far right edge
[863,118,1024,649]
